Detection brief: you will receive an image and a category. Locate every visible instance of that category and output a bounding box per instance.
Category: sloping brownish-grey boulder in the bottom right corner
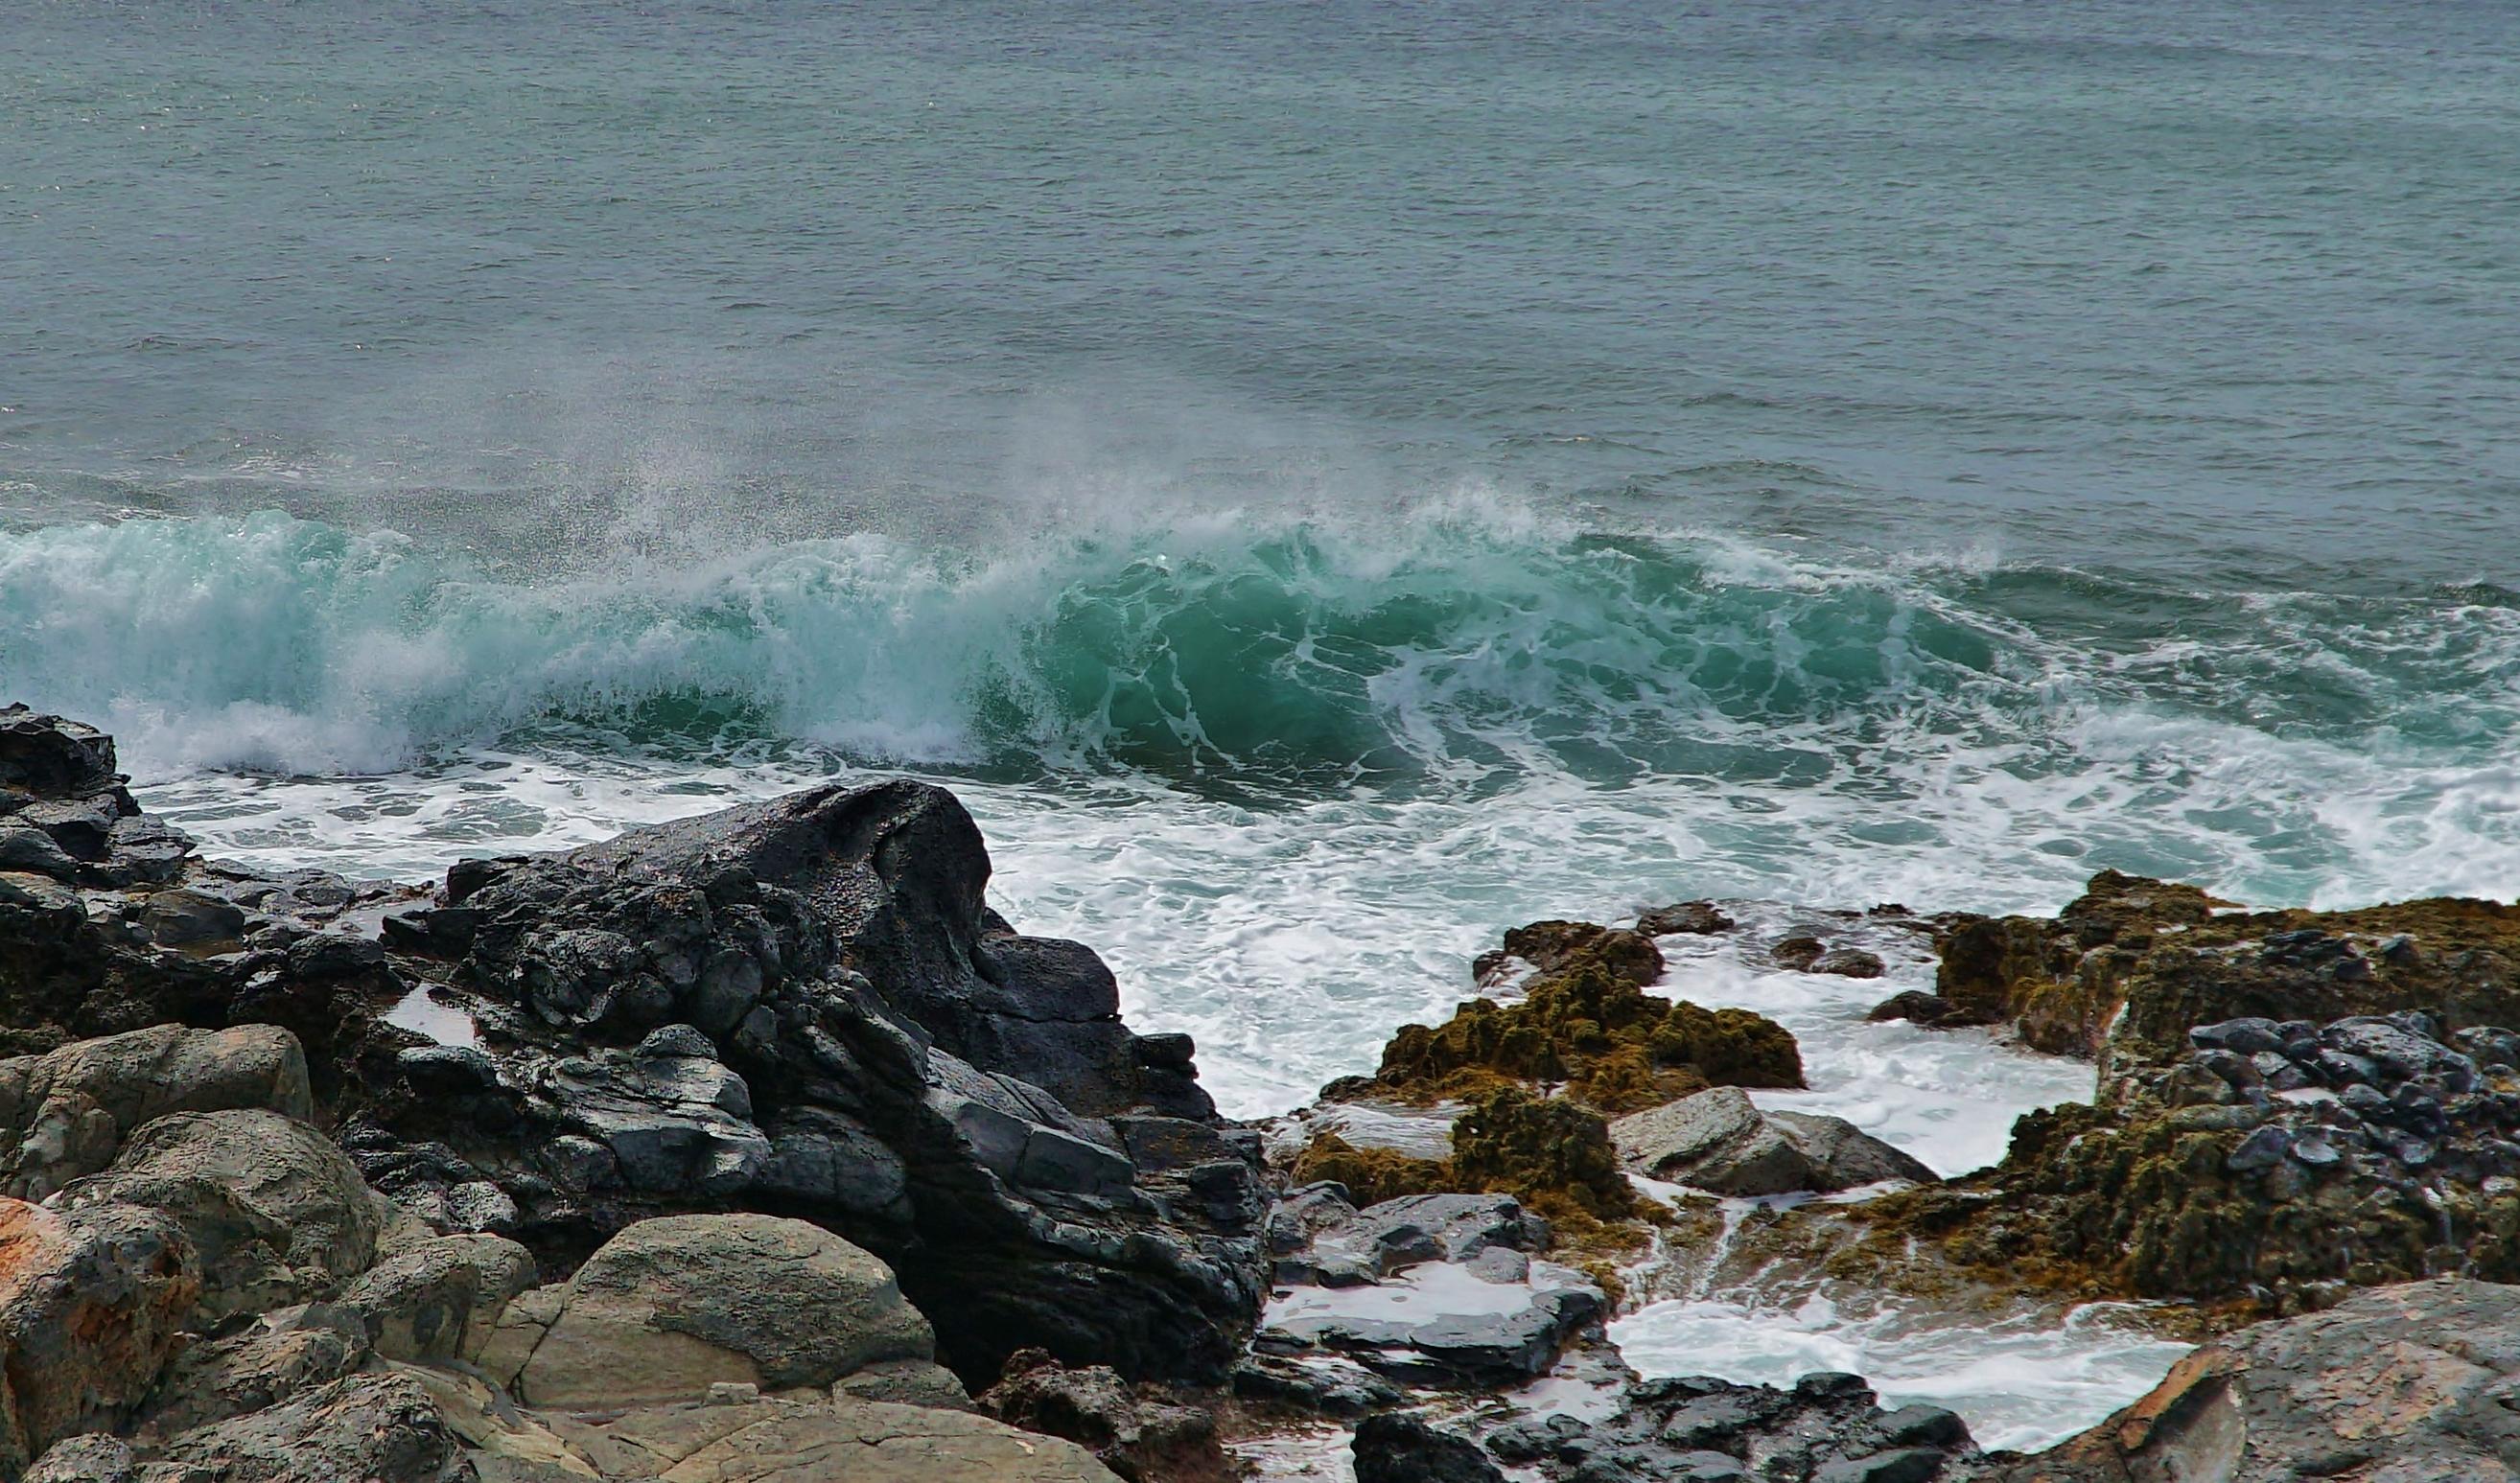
[1995,1277,2520,1483]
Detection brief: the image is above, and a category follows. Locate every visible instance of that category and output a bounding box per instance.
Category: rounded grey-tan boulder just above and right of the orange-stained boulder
[60,1108,383,1322]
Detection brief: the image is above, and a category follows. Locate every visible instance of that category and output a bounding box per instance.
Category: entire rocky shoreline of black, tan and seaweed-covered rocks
[0,707,2520,1483]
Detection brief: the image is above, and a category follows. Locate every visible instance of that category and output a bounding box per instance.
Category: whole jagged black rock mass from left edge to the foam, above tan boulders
[0,707,1265,1382]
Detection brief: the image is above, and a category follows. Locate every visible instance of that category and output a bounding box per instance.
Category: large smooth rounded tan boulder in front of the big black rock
[481,1217,935,1407]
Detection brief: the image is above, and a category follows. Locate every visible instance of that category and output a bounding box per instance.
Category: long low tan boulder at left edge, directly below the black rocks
[0,1025,315,1198]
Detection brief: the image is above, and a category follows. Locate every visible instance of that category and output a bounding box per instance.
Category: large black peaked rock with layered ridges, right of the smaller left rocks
[353,783,1265,1382]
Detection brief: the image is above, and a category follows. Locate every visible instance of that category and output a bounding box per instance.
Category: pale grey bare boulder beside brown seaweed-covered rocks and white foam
[1610,1088,1935,1196]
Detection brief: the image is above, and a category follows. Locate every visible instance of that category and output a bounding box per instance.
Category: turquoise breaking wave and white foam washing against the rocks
[0,494,2520,1446]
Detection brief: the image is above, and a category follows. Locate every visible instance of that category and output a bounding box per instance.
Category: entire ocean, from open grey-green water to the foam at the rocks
[0,0,2520,1438]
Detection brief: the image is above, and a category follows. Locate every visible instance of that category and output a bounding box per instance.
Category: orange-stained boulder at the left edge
[0,1198,199,1475]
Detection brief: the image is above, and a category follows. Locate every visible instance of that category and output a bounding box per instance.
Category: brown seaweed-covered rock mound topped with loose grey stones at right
[1865,1012,2520,1311]
